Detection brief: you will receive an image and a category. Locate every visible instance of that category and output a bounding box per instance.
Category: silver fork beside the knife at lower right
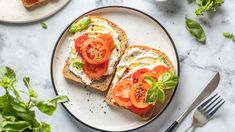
[185,94,225,132]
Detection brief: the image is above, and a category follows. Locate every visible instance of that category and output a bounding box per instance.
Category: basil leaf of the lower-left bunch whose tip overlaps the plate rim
[31,96,69,116]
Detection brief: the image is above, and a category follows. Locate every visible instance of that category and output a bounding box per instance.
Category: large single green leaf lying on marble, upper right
[185,17,206,43]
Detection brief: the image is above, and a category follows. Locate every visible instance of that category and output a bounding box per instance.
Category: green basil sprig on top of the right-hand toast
[144,72,178,103]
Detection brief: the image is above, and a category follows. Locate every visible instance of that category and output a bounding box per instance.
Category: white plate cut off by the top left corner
[0,0,70,23]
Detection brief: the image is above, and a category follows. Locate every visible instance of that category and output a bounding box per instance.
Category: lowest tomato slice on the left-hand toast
[83,61,108,79]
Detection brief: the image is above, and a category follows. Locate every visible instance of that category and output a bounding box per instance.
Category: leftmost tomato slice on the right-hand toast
[112,79,132,108]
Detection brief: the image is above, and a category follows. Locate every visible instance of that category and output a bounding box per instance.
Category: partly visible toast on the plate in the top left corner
[21,0,49,10]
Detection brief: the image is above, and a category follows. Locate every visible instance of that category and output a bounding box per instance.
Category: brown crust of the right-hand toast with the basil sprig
[105,45,174,120]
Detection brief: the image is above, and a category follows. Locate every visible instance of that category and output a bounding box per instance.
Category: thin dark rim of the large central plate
[50,6,180,132]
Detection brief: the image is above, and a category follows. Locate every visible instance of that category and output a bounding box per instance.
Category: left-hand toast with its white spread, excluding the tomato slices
[63,16,127,91]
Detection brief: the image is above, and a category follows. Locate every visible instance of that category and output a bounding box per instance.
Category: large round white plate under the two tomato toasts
[51,6,179,131]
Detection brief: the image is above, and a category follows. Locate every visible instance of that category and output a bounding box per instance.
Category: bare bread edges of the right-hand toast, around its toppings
[105,45,174,120]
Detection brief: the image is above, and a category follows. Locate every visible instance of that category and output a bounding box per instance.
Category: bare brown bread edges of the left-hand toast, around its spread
[63,16,127,91]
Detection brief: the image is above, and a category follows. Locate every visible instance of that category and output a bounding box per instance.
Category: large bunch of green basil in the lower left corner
[0,66,69,132]
